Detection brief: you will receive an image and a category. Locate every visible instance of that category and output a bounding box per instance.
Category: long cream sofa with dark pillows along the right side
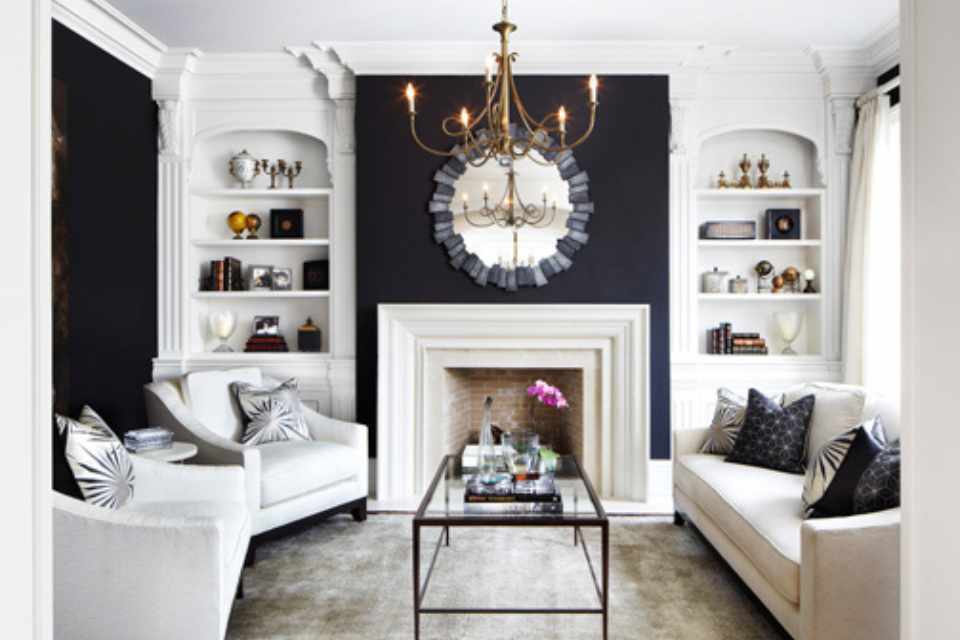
[673,384,900,640]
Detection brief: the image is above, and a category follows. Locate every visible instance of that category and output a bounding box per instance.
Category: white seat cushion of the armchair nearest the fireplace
[257,440,357,507]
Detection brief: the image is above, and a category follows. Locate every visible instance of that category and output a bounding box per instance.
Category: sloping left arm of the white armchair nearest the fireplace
[143,381,260,513]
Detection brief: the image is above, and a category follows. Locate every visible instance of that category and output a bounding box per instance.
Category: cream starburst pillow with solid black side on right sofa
[803,417,887,517]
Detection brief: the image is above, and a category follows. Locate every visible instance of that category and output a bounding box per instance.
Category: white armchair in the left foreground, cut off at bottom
[53,456,250,640]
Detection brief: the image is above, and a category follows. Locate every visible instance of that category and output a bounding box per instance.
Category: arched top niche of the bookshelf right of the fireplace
[694,128,824,189]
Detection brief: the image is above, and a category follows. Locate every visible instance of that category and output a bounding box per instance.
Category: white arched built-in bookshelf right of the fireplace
[688,131,834,364]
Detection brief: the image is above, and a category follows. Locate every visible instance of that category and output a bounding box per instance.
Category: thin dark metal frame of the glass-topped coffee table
[413,455,610,640]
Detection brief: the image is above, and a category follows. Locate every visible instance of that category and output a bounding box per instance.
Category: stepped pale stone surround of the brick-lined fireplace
[375,304,650,504]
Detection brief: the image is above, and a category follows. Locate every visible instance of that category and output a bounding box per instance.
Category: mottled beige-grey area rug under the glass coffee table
[227,515,787,640]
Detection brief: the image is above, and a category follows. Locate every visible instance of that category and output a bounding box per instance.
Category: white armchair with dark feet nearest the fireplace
[144,368,368,536]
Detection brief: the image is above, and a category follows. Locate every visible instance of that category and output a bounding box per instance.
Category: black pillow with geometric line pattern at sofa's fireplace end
[726,389,816,473]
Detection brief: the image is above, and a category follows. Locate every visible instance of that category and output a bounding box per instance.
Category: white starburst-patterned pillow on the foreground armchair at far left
[56,407,134,509]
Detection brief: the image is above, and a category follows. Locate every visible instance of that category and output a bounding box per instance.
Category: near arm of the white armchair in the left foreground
[53,494,232,639]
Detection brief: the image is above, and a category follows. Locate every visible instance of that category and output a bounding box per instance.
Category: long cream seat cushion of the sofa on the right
[674,453,803,603]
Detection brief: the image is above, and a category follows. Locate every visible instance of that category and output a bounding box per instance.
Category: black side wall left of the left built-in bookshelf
[53,22,157,433]
